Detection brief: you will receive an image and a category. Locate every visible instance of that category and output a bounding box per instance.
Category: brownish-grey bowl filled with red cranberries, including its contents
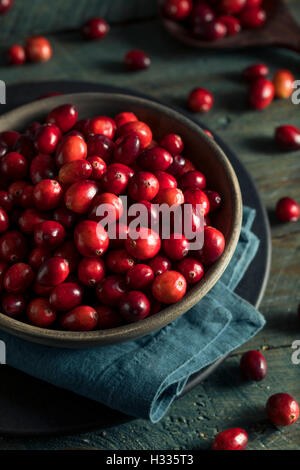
[0,93,242,347]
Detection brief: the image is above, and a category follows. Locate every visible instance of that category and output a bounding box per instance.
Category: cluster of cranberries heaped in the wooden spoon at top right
[163,0,267,41]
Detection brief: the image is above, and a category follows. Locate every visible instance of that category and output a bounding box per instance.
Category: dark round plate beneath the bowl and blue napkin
[0,82,271,437]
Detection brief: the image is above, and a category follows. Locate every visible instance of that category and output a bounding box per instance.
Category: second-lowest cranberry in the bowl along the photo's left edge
[3,263,34,294]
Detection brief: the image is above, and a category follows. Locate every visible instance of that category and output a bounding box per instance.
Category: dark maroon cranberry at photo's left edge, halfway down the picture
[0,230,27,263]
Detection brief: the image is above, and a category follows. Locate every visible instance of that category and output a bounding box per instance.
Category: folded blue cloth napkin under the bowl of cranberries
[0,207,265,423]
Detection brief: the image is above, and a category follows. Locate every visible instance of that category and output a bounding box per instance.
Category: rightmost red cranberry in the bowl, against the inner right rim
[199,226,225,264]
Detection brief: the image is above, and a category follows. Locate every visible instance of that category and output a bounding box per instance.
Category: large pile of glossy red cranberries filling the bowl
[0,104,225,331]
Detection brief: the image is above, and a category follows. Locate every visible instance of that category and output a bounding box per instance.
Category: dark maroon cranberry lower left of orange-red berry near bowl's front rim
[119,290,150,322]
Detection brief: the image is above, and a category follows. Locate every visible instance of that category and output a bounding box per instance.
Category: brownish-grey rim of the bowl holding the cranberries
[0,92,242,348]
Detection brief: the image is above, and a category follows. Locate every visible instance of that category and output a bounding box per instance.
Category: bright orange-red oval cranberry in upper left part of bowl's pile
[54,135,87,167]
